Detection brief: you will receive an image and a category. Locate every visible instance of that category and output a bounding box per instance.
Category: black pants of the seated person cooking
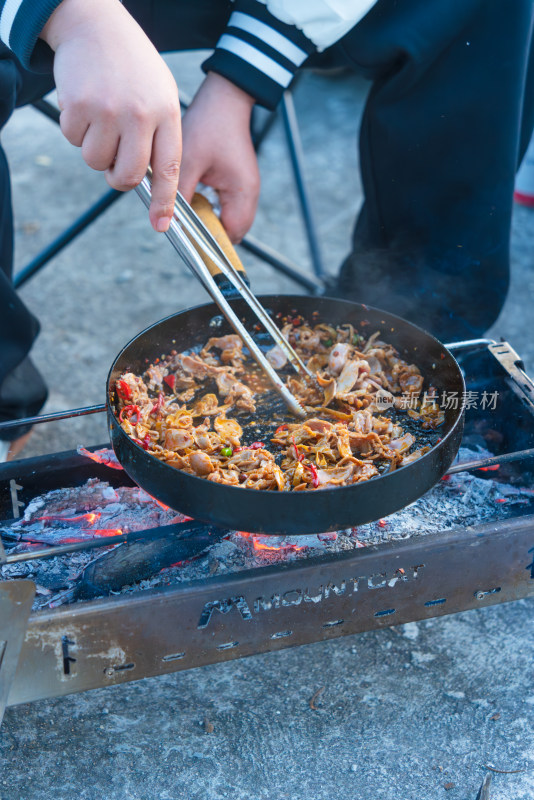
[0,0,534,435]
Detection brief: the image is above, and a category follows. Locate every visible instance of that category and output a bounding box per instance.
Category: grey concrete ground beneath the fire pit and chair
[0,55,534,800]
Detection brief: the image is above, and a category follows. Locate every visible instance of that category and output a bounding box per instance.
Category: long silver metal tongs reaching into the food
[136,167,314,417]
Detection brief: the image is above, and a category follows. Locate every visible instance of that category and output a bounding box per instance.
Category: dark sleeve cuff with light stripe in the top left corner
[0,0,61,70]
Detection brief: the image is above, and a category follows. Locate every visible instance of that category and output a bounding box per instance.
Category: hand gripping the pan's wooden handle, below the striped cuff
[178,72,260,243]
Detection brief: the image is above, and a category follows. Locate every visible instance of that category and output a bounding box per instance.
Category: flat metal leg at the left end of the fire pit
[0,581,35,725]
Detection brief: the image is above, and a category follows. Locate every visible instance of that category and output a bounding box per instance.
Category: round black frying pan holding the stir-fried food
[107,295,465,535]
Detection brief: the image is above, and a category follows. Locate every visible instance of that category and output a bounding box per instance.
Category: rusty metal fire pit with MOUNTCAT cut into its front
[0,343,534,711]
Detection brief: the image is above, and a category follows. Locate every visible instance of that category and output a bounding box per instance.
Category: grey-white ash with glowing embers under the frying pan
[0,448,534,609]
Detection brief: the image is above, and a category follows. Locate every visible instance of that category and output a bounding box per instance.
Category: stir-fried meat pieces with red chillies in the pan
[115,318,444,491]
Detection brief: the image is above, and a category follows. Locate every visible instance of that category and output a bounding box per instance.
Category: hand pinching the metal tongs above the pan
[41,0,181,232]
